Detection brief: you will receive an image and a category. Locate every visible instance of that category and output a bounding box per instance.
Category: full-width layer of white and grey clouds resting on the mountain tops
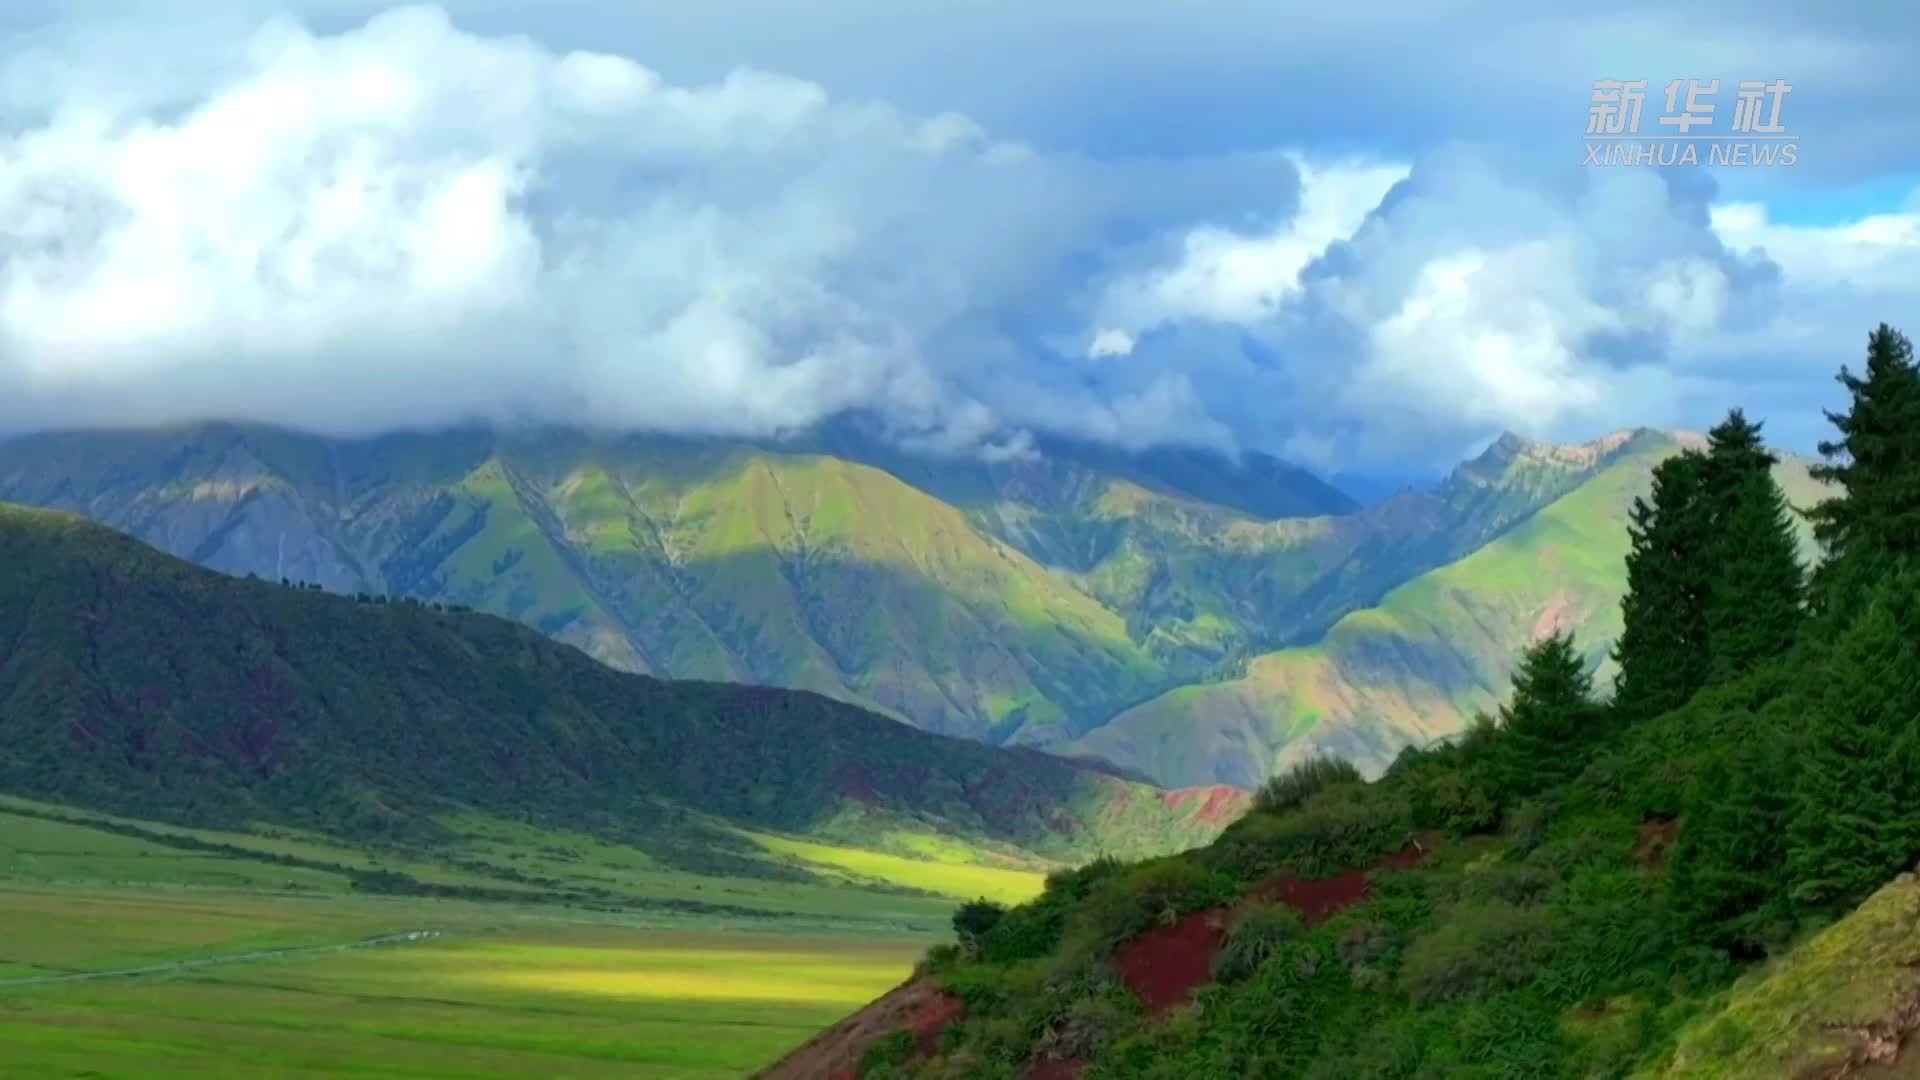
[0,4,1920,463]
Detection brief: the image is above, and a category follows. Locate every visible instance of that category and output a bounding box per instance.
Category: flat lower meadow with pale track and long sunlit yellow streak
[0,886,925,1080]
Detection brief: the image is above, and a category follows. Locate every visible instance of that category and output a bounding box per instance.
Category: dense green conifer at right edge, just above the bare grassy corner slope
[1788,575,1920,911]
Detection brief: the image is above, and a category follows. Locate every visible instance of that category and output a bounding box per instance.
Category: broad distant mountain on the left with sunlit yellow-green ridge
[0,427,1167,742]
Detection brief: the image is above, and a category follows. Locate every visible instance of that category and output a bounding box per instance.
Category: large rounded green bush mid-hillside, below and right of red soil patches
[1400,899,1555,1003]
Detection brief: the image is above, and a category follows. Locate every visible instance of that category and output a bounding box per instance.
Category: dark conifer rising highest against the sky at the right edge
[1811,323,1920,611]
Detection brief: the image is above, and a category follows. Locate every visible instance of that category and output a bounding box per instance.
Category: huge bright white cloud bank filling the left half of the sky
[0,10,1067,441]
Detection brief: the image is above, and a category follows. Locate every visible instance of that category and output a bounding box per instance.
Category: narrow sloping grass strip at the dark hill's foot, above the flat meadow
[0,796,1043,936]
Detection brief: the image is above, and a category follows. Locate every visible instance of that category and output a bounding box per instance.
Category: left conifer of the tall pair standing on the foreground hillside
[1613,452,1713,721]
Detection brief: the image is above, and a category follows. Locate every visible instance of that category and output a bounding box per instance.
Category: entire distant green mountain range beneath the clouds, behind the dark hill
[0,423,1812,786]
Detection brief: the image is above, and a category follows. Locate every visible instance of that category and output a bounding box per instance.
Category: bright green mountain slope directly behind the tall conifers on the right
[1069,430,1816,786]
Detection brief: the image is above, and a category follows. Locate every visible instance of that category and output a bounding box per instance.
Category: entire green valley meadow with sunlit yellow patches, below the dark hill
[0,799,1031,1080]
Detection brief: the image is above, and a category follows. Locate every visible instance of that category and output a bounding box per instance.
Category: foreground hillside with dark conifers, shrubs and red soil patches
[787,327,1920,1080]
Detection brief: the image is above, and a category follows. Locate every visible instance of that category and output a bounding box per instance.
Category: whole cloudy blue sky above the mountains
[0,0,1920,473]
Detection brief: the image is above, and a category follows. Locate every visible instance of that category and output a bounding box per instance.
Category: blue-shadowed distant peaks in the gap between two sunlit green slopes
[835,424,1620,680]
